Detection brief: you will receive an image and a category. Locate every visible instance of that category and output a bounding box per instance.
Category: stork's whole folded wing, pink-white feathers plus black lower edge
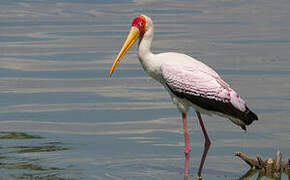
[161,64,258,124]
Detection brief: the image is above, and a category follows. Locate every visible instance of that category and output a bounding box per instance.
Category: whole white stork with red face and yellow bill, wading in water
[110,14,258,178]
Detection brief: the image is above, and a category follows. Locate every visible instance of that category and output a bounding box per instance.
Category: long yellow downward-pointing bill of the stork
[110,26,140,77]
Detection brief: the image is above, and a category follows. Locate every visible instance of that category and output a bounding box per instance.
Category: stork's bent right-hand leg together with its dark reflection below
[196,111,211,178]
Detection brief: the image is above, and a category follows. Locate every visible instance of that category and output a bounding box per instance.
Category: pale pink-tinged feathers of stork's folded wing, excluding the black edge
[161,64,246,112]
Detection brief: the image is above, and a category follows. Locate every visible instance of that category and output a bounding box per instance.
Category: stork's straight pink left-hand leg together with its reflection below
[182,113,190,177]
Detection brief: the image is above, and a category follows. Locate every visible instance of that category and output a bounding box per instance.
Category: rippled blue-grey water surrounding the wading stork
[0,0,290,180]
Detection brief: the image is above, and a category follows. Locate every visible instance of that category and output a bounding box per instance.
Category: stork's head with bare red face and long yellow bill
[110,14,153,77]
